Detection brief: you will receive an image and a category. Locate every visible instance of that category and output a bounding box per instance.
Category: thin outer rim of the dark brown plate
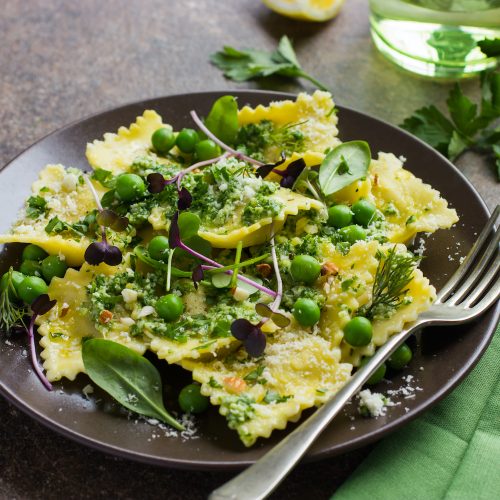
[0,89,500,471]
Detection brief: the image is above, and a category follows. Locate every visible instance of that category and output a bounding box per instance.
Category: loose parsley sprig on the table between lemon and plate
[210,36,328,90]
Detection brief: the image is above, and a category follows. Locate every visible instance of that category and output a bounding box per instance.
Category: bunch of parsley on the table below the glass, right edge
[401,70,500,180]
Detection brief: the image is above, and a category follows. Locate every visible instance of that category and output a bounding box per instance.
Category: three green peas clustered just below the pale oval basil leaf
[327,199,377,244]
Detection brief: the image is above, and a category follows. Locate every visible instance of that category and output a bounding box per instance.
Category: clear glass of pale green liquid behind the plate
[370,0,500,80]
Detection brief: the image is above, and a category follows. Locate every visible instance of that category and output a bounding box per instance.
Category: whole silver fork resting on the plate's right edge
[209,206,500,500]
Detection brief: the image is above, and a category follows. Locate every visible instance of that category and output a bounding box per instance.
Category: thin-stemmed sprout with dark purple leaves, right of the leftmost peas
[83,174,129,266]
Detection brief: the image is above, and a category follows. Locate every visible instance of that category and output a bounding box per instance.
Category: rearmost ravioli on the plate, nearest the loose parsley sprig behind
[238,90,340,161]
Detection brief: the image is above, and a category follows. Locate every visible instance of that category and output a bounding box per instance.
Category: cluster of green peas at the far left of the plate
[0,244,68,304]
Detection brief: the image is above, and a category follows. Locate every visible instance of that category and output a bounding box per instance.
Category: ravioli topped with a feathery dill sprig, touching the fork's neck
[318,241,436,366]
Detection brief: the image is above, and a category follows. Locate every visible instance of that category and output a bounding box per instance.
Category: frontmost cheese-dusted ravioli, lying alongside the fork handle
[182,326,352,446]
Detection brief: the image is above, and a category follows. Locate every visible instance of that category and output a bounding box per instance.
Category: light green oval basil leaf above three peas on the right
[318,141,371,196]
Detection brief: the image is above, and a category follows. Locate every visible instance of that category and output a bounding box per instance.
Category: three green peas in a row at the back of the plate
[151,125,221,161]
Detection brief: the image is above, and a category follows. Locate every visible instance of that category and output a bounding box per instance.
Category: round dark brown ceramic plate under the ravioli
[0,91,496,469]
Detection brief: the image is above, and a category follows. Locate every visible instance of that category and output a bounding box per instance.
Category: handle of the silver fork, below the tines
[209,318,427,500]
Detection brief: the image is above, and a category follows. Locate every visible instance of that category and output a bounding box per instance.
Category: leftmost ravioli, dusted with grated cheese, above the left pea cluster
[0,165,102,266]
